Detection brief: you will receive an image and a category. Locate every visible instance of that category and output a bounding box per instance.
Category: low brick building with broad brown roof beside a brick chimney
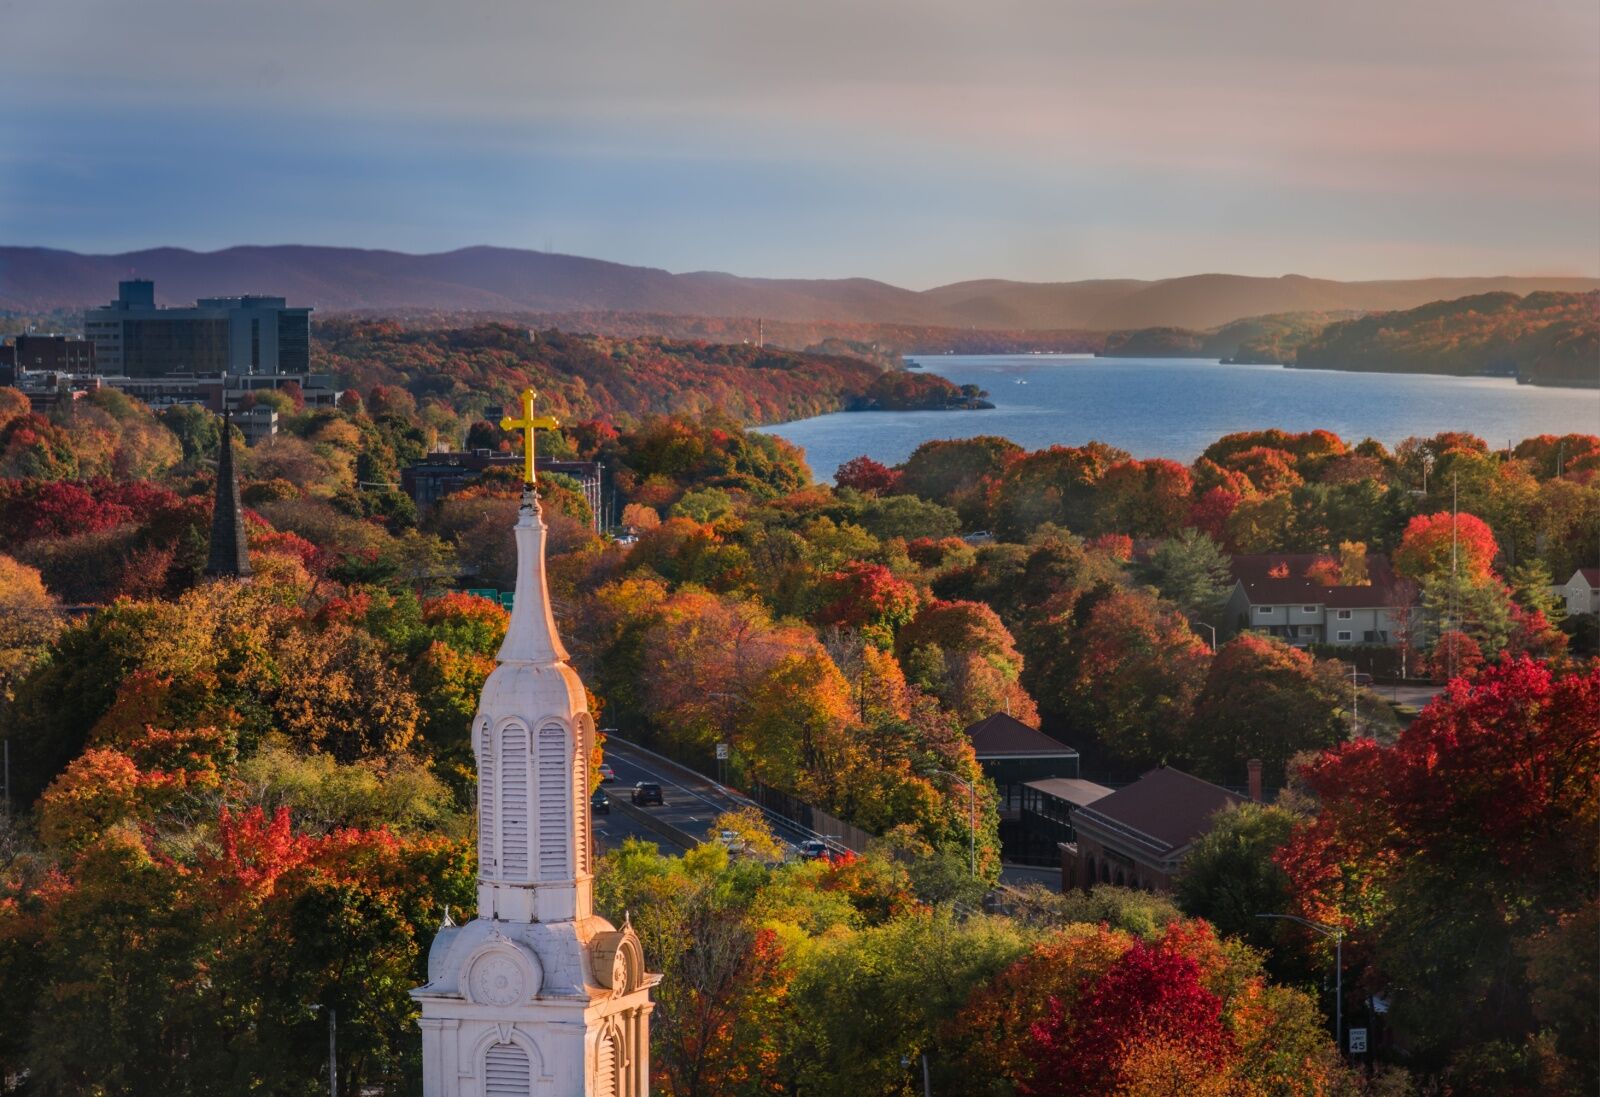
[1061,766,1245,891]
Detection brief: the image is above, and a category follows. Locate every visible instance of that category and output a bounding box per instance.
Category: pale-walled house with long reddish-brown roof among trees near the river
[1222,552,1416,648]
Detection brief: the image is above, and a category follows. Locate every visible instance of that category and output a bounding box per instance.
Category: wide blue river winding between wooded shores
[765,355,1600,480]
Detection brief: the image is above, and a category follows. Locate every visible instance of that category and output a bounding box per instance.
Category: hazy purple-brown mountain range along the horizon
[0,245,1600,331]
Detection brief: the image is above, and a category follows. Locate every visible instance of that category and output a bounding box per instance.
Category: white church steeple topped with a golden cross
[411,392,659,1097]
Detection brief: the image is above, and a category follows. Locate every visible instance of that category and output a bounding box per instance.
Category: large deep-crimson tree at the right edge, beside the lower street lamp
[1278,659,1600,1070]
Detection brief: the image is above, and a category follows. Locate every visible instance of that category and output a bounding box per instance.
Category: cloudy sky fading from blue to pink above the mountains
[0,0,1600,288]
